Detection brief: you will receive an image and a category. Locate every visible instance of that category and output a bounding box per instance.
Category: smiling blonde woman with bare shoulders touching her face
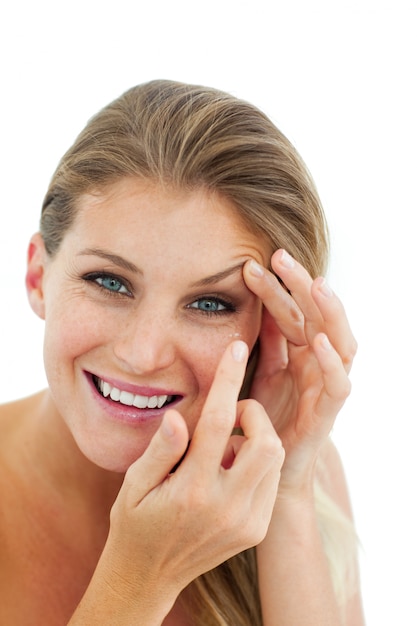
[0,81,363,626]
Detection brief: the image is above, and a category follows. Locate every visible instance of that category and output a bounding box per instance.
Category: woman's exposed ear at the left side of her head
[26,233,47,319]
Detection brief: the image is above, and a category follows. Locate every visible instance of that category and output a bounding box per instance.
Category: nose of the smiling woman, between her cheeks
[114,307,176,375]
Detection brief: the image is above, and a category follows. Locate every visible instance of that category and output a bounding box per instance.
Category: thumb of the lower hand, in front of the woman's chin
[122,409,188,507]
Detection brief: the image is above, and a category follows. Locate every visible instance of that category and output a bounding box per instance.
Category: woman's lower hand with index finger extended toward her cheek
[92,341,284,615]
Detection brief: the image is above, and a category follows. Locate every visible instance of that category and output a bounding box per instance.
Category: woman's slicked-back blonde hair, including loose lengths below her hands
[41,80,352,626]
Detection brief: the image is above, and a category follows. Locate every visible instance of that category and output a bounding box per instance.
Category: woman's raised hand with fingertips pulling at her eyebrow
[244,250,356,494]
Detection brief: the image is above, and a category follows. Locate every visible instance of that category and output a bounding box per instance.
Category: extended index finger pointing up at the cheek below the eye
[187,341,249,471]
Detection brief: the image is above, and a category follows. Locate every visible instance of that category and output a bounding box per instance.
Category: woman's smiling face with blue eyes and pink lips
[29,179,269,471]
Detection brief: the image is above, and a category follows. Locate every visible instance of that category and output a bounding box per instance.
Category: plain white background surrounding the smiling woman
[0,0,417,626]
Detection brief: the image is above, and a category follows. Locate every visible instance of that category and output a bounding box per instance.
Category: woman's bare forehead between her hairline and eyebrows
[70,178,271,263]
